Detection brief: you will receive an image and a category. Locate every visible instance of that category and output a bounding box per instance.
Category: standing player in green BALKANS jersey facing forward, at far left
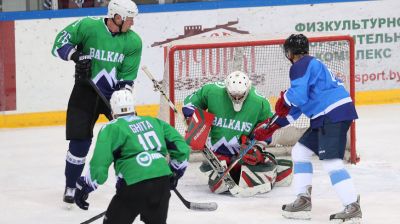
[52,0,142,206]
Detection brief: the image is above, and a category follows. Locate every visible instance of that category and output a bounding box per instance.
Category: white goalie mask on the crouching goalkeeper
[225,71,251,112]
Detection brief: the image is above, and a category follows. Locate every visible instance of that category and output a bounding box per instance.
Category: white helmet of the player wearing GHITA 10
[110,89,135,118]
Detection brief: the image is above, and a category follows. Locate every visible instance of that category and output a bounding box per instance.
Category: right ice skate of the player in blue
[329,196,362,224]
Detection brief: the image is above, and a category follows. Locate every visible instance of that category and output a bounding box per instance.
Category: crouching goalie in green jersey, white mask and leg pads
[182,71,292,196]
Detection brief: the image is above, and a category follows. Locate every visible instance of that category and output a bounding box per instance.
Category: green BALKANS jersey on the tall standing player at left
[52,17,142,97]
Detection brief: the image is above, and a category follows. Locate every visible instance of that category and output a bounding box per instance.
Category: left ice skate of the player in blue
[282,186,312,220]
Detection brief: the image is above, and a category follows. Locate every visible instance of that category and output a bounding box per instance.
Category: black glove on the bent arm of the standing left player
[71,51,92,80]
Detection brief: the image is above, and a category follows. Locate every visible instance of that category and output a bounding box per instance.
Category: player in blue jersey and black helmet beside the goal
[255,34,362,223]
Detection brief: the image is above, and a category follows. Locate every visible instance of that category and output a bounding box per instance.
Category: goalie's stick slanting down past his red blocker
[142,66,242,195]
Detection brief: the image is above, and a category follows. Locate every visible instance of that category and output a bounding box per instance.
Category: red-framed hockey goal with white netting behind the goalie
[159,35,358,163]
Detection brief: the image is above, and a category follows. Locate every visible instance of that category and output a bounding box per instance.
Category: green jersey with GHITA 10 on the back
[86,115,190,185]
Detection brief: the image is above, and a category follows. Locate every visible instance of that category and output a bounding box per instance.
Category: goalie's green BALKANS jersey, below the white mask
[183,82,272,155]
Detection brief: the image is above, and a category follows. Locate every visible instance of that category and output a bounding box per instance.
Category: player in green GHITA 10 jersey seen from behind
[75,89,190,224]
